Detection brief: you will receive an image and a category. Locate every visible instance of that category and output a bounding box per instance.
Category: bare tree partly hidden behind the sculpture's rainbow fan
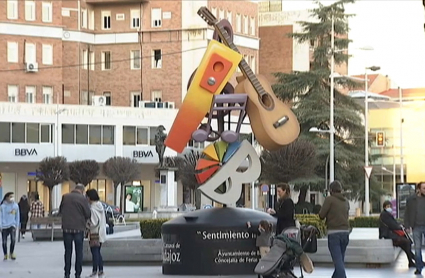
[174,150,202,209]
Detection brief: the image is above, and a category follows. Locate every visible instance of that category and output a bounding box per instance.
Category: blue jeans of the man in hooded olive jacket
[328,232,350,278]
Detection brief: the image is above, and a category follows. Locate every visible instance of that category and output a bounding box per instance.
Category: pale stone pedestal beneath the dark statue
[159,168,178,208]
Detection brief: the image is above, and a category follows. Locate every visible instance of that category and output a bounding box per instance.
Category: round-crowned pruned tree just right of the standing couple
[102,156,140,213]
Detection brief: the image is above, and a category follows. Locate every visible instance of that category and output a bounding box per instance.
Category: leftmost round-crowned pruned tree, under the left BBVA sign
[36,156,69,210]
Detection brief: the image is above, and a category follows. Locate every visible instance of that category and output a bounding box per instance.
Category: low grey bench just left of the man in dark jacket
[29,217,63,241]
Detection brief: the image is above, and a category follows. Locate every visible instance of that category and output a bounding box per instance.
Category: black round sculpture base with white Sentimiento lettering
[162,207,276,276]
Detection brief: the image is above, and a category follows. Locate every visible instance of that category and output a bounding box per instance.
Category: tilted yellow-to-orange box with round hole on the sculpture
[164,40,242,153]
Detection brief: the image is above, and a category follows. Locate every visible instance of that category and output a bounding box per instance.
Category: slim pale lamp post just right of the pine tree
[364,66,381,216]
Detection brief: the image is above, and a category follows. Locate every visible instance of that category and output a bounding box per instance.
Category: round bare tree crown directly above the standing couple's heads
[69,160,100,186]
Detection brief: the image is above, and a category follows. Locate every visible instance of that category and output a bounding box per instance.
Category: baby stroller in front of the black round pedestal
[254,226,318,278]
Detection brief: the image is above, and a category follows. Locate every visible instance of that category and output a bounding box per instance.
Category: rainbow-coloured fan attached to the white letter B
[195,141,241,184]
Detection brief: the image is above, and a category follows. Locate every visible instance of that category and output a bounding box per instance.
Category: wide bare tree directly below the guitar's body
[260,139,317,205]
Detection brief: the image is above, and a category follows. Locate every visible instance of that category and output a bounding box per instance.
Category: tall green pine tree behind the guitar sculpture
[273,0,381,201]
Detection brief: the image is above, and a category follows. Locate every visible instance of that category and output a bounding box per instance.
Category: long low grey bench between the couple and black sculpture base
[83,238,162,264]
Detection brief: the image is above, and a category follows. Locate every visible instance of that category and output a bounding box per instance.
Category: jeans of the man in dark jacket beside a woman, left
[63,232,84,277]
